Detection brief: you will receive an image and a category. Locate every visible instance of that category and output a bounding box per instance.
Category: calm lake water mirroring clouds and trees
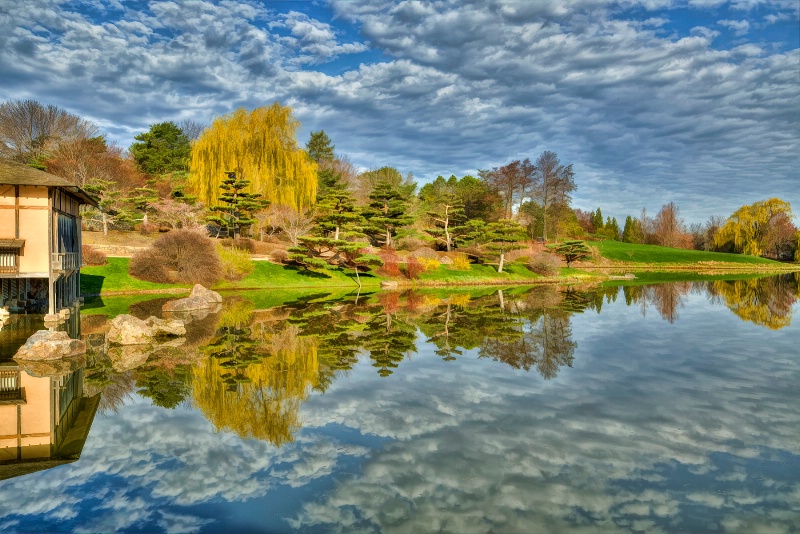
[0,275,800,533]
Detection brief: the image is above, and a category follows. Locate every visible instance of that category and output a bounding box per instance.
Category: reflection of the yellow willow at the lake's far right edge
[713,278,797,330]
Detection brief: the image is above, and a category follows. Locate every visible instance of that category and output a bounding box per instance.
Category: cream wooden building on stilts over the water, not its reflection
[0,159,96,313]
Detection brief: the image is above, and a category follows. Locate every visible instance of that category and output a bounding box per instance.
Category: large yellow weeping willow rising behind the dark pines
[188,102,317,212]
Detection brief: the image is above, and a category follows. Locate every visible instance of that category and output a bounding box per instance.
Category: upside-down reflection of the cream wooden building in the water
[0,365,100,480]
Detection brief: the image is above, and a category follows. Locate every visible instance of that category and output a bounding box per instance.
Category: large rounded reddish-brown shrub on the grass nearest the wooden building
[129,230,221,286]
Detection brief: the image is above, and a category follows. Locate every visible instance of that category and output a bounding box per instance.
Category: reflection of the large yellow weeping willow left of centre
[192,335,319,446]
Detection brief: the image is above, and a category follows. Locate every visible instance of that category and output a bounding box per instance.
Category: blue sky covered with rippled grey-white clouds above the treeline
[0,0,800,223]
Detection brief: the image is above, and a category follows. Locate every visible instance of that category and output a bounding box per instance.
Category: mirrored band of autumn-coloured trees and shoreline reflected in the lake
[78,275,799,445]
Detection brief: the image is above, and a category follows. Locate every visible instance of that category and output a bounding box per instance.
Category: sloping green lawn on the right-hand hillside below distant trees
[587,240,783,266]
